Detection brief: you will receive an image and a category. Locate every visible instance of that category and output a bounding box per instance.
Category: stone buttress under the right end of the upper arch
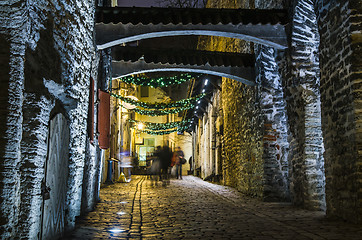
[255,45,290,201]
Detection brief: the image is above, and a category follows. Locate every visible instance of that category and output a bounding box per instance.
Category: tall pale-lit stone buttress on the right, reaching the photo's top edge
[281,0,325,210]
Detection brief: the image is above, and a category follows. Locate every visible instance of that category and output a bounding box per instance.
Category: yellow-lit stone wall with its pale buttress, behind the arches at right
[195,1,289,201]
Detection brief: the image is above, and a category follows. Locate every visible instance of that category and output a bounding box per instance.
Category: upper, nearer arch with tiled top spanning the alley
[95,8,287,49]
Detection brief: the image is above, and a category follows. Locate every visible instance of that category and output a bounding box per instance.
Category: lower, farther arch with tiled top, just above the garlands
[112,47,255,86]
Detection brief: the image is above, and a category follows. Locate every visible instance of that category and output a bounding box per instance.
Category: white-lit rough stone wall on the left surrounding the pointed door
[0,0,96,239]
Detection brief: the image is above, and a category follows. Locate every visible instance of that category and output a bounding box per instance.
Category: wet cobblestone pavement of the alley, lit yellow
[64,176,362,240]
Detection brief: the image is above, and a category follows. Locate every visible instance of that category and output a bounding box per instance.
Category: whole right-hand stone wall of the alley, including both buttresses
[200,0,361,221]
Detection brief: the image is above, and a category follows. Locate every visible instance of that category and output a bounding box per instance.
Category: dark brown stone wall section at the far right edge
[316,0,362,222]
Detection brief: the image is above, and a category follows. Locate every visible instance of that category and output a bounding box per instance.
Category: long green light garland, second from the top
[111,93,206,109]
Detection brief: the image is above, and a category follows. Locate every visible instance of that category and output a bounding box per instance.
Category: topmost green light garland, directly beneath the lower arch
[119,73,202,88]
